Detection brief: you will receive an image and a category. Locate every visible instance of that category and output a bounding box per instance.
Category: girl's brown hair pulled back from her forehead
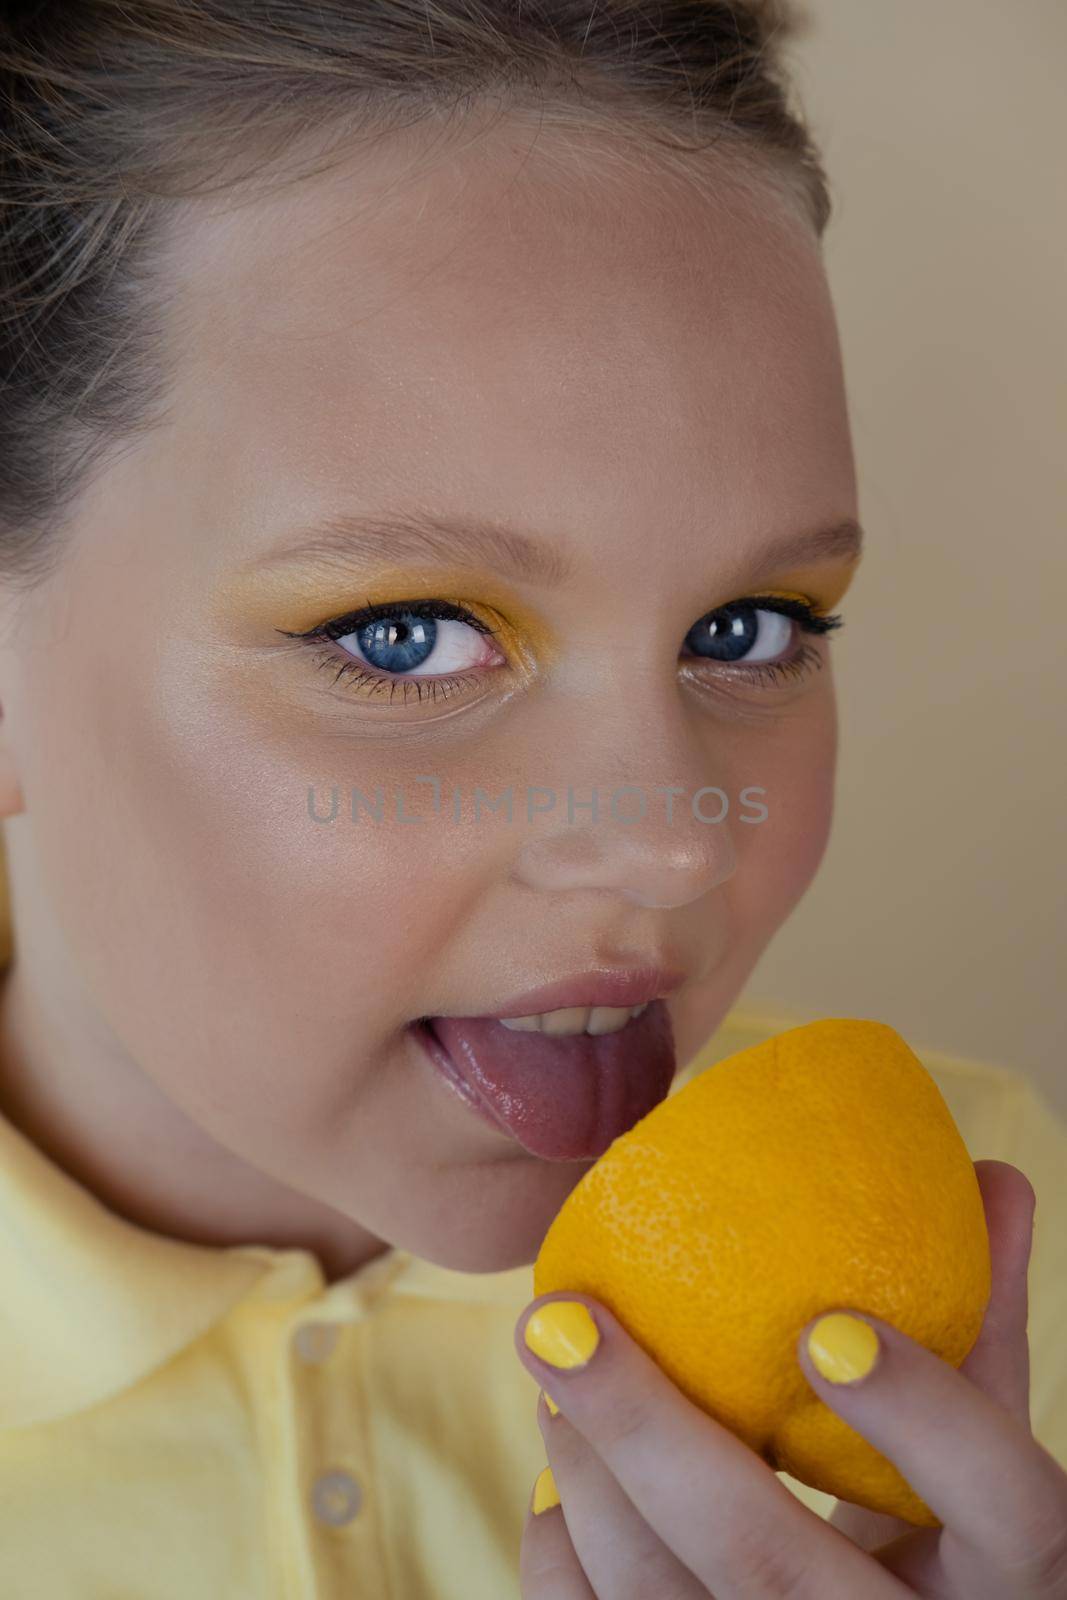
[0,0,830,584]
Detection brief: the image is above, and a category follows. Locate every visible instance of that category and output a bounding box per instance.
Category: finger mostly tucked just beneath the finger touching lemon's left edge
[537,1400,709,1600]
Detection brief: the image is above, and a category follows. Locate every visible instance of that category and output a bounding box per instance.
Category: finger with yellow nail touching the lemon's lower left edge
[515,1293,904,1600]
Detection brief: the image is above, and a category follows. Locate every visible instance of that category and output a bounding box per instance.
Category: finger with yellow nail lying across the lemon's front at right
[797,1307,1067,1573]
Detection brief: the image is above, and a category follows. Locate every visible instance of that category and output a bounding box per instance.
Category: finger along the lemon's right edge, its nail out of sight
[960,1160,1037,1427]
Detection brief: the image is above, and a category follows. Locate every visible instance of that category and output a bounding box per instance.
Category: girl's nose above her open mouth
[512,707,742,909]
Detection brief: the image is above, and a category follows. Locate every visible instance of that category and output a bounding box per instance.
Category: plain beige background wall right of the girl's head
[742,0,1067,1115]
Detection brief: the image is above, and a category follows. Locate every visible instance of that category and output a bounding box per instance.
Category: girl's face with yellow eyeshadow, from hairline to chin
[0,124,856,1270]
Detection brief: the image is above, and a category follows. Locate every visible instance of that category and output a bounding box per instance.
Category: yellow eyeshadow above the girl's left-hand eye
[216,563,558,669]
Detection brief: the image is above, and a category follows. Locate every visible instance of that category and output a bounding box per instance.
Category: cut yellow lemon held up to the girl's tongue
[533,1018,992,1528]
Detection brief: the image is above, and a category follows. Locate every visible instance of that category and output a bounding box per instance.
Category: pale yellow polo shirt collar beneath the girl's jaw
[0,1088,533,1429]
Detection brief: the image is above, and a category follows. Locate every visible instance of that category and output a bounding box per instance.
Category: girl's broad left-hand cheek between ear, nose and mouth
[20,620,495,1150]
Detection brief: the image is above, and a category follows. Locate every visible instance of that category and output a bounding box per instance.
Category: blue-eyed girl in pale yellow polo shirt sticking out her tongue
[0,0,1067,1600]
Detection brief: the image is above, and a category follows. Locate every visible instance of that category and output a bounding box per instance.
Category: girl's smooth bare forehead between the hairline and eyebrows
[154,118,851,550]
